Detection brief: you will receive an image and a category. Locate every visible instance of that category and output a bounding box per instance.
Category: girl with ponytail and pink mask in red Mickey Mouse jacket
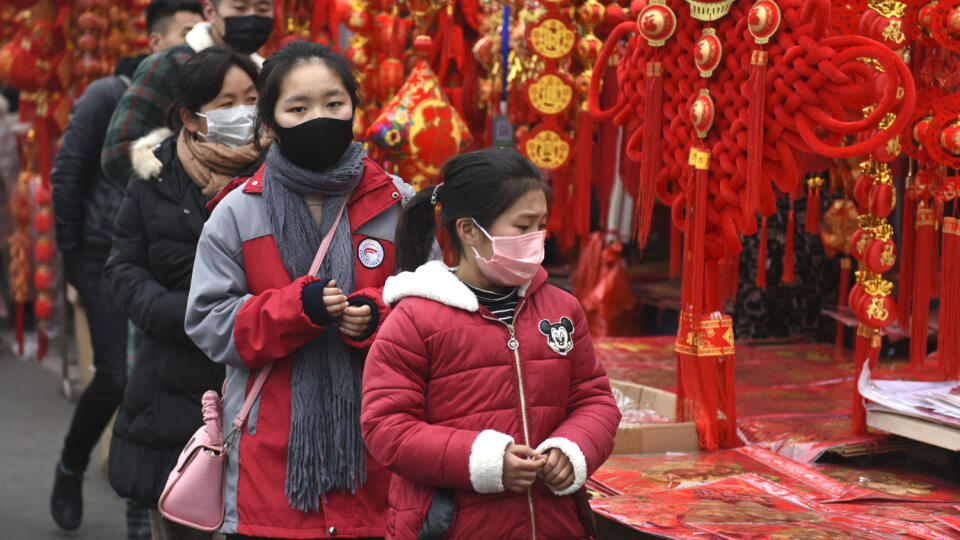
[361,148,620,540]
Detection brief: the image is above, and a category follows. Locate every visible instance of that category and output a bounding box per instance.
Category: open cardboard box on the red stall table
[610,381,700,454]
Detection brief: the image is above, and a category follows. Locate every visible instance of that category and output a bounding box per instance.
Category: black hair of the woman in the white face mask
[167,46,257,131]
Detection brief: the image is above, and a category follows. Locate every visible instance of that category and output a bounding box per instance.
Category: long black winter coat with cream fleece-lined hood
[105,130,258,507]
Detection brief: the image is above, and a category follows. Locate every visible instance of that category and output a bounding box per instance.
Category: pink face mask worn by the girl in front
[473,220,547,287]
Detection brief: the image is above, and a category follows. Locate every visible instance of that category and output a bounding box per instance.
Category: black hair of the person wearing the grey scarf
[255,40,360,151]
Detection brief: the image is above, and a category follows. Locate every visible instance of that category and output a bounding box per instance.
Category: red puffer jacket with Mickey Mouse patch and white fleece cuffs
[361,261,620,540]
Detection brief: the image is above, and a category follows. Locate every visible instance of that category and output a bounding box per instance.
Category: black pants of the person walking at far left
[60,258,127,472]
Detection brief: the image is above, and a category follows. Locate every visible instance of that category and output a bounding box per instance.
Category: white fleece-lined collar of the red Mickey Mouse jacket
[383,261,547,312]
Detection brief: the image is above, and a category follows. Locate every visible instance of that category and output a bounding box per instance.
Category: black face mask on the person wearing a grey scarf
[273,118,353,172]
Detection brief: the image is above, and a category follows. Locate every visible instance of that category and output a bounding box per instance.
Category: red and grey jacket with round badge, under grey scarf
[185,159,412,538]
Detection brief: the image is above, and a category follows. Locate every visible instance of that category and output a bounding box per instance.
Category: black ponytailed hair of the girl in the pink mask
[395,148,553,272]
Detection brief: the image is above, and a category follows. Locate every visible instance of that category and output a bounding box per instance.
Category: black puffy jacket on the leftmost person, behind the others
[50,55,146,263]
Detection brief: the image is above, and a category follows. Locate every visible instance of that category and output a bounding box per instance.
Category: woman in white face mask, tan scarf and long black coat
[105,48,260,540]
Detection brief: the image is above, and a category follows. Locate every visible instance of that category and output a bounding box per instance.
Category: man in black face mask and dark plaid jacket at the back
[101,0,274,184]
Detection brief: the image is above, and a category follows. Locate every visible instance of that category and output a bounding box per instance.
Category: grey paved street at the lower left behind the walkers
[0,332,126,540]
